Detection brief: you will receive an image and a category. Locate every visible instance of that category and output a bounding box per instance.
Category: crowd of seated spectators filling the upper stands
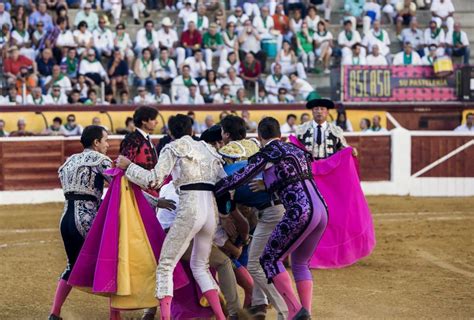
[0,0,470,105]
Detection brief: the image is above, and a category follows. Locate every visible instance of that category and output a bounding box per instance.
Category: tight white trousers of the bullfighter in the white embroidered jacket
[156,190,219,299]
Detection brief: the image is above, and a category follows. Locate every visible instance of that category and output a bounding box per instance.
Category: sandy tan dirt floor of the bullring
[0,197,474,320]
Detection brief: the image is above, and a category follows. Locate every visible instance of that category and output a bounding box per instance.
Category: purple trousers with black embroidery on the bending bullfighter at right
[260,180,328,282]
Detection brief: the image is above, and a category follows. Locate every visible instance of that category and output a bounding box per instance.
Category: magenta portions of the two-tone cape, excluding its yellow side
[68,169,189,295]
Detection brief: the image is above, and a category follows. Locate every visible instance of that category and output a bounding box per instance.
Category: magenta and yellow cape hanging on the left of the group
[69,169,189,310]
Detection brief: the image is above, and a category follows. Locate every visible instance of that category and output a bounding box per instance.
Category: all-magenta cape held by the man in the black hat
[289,136,375,269]
